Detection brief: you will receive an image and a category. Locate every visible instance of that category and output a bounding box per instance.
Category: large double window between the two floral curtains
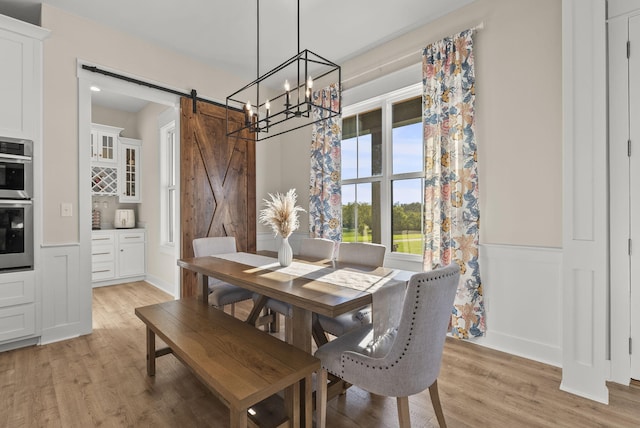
[342,85,424,255]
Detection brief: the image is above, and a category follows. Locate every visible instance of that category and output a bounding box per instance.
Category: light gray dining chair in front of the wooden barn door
[193,236,253,316]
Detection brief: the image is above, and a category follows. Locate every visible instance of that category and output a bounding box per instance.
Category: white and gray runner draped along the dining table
[212,253,406,347]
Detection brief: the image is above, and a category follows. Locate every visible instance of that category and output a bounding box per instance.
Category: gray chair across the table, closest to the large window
[314,242,387,345]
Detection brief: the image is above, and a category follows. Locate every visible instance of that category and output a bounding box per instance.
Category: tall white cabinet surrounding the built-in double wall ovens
[0,15,49,351]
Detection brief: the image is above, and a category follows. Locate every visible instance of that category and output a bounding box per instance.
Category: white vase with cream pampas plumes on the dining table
[258,189,304,266]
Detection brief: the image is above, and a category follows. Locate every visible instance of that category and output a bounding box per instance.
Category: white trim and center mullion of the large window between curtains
[342,82,424,262]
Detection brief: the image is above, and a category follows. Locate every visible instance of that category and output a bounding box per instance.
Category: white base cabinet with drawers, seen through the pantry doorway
[91,229,146,287]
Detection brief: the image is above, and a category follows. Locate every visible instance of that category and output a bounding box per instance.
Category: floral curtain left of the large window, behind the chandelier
[309,84,342,242]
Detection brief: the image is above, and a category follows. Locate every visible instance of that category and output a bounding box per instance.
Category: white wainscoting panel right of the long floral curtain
[474,244,562,366]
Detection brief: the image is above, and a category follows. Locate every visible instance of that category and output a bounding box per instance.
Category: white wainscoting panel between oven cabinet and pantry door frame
[41,244,91,344]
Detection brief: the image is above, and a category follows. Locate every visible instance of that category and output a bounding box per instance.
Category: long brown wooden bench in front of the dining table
[135,298,320,428]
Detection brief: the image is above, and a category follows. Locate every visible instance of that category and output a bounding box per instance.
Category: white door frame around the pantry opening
[76,58,180,332]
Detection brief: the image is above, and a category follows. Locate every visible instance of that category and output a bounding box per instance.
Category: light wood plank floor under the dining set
[0,282,640,428]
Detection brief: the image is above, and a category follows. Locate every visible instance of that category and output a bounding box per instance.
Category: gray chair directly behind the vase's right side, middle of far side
[253,238,335,341]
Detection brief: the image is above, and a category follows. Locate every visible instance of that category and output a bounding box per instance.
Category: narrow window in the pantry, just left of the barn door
[160,121,178,247]
